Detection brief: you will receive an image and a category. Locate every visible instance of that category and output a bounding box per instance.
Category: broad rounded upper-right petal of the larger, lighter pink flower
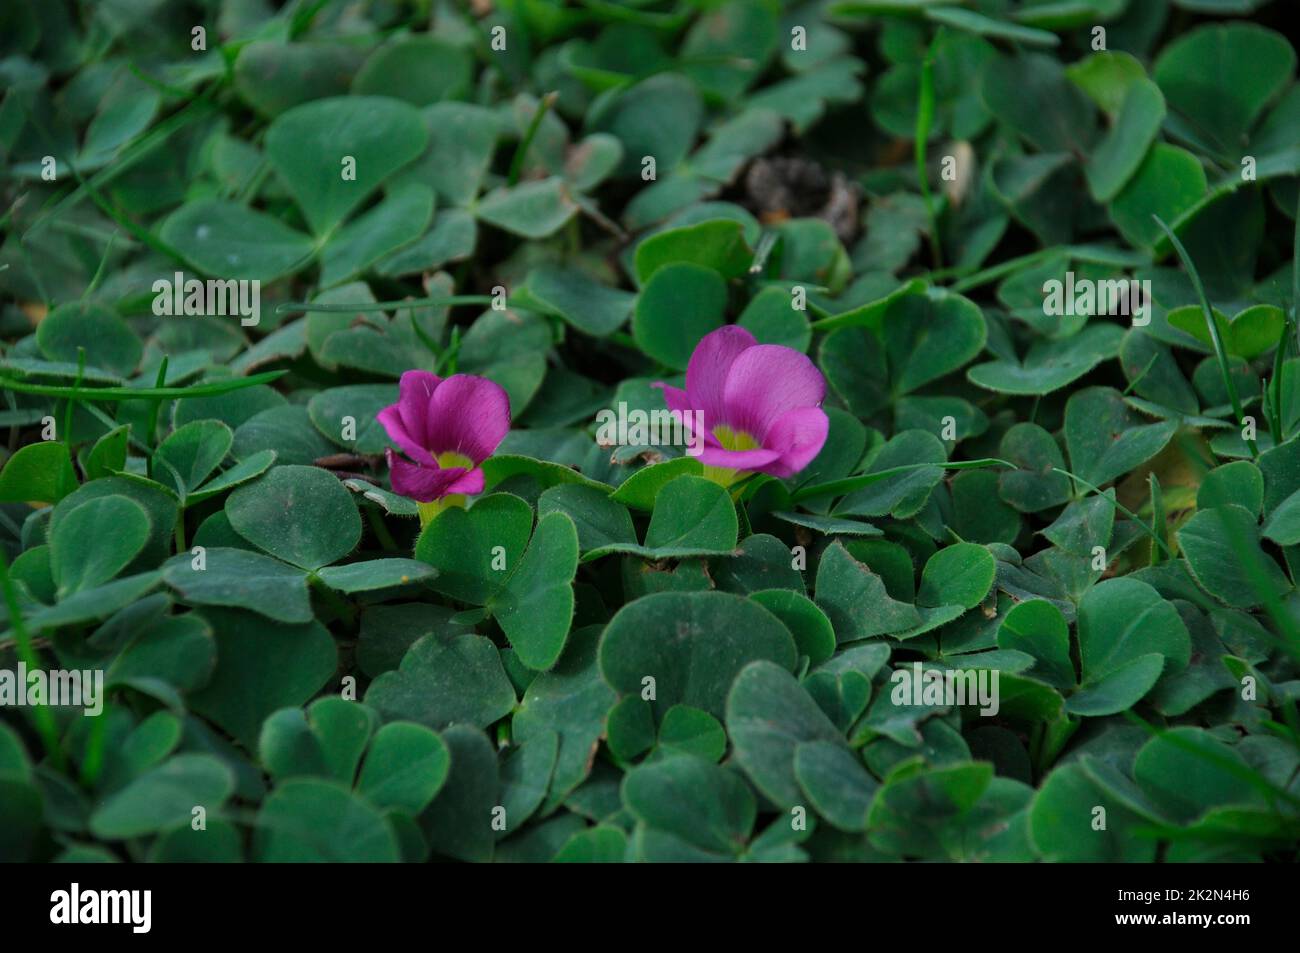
[717,345,826,446]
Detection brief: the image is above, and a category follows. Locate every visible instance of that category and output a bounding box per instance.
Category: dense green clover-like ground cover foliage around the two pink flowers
[0,0,1300,862]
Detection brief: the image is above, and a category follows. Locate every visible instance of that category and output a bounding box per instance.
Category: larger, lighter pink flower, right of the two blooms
[654,325,829,485]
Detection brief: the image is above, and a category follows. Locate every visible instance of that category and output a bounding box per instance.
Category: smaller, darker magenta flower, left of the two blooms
[377,371,510,503]
